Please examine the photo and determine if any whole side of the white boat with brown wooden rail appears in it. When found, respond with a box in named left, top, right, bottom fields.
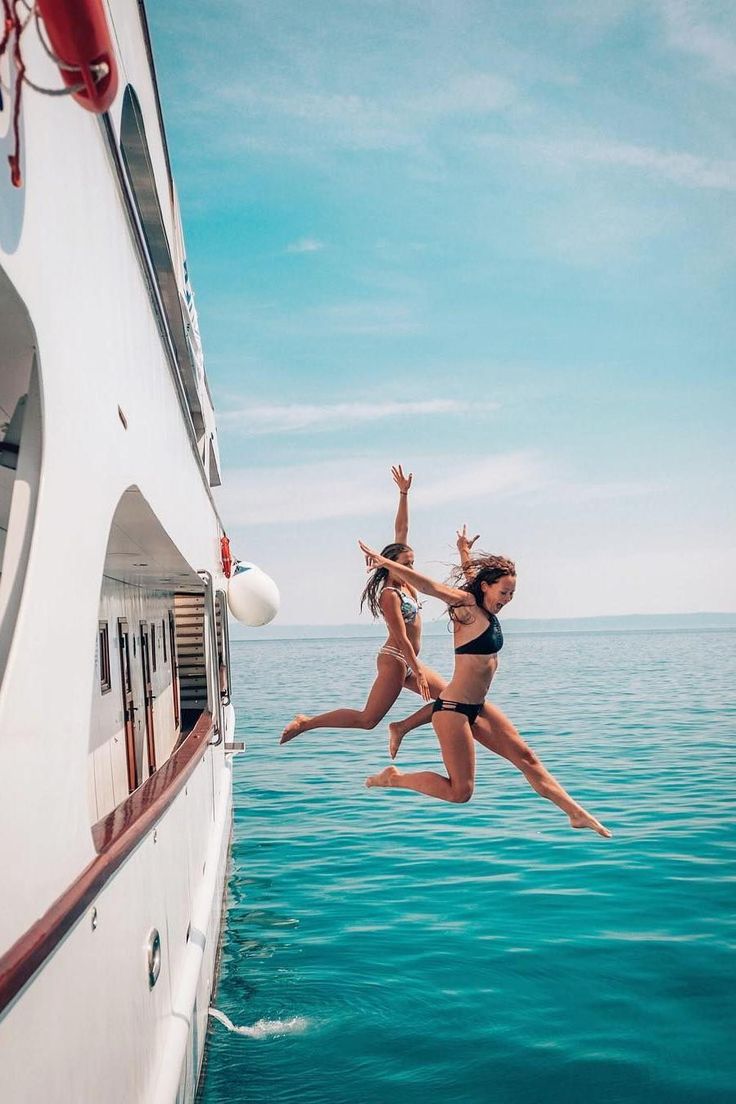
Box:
left=0, top=0, right=234, bottom=1104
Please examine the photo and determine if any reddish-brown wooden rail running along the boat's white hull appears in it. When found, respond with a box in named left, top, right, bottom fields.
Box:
left=0, top=712, right=213, bottom=1015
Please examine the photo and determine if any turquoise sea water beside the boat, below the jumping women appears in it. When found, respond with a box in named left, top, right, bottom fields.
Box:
left=201, top=631, right=736, bottom=1104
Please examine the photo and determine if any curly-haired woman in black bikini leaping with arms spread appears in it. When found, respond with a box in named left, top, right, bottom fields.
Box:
left=359, top=530, right=611, bottom=838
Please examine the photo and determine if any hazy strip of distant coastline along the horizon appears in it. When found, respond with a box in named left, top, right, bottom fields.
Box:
left=231, top=613, right=736, bottom=640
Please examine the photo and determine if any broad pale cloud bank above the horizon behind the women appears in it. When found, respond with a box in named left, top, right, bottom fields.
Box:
left=217, top=470, right=736, bottom=627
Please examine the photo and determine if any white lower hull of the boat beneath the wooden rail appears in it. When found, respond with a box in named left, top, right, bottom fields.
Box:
left=0, top=733, right=231, bottom=1104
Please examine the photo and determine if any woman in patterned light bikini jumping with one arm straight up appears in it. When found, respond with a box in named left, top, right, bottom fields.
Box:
left=280, top=464, right=445, bottom=744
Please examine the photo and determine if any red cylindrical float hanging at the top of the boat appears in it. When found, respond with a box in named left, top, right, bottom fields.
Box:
left=36, top=0, right=118, bottom=115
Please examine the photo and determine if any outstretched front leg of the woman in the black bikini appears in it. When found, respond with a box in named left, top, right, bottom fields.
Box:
left=472, top=702, right=611, bottom=838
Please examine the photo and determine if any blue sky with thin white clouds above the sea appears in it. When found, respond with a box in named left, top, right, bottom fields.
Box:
left=148, top=0, right=736, bottom=624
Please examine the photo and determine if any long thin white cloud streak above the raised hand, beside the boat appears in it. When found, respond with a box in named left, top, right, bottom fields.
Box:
left=218, top=399, right=499, bottom=436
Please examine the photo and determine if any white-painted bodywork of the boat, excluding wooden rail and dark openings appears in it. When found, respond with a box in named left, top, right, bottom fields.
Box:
left=0, top=0, right=242, bottom=1104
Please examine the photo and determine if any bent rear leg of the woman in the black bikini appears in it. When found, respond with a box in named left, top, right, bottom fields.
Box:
left=365, top=711, right=476, bottom=803
